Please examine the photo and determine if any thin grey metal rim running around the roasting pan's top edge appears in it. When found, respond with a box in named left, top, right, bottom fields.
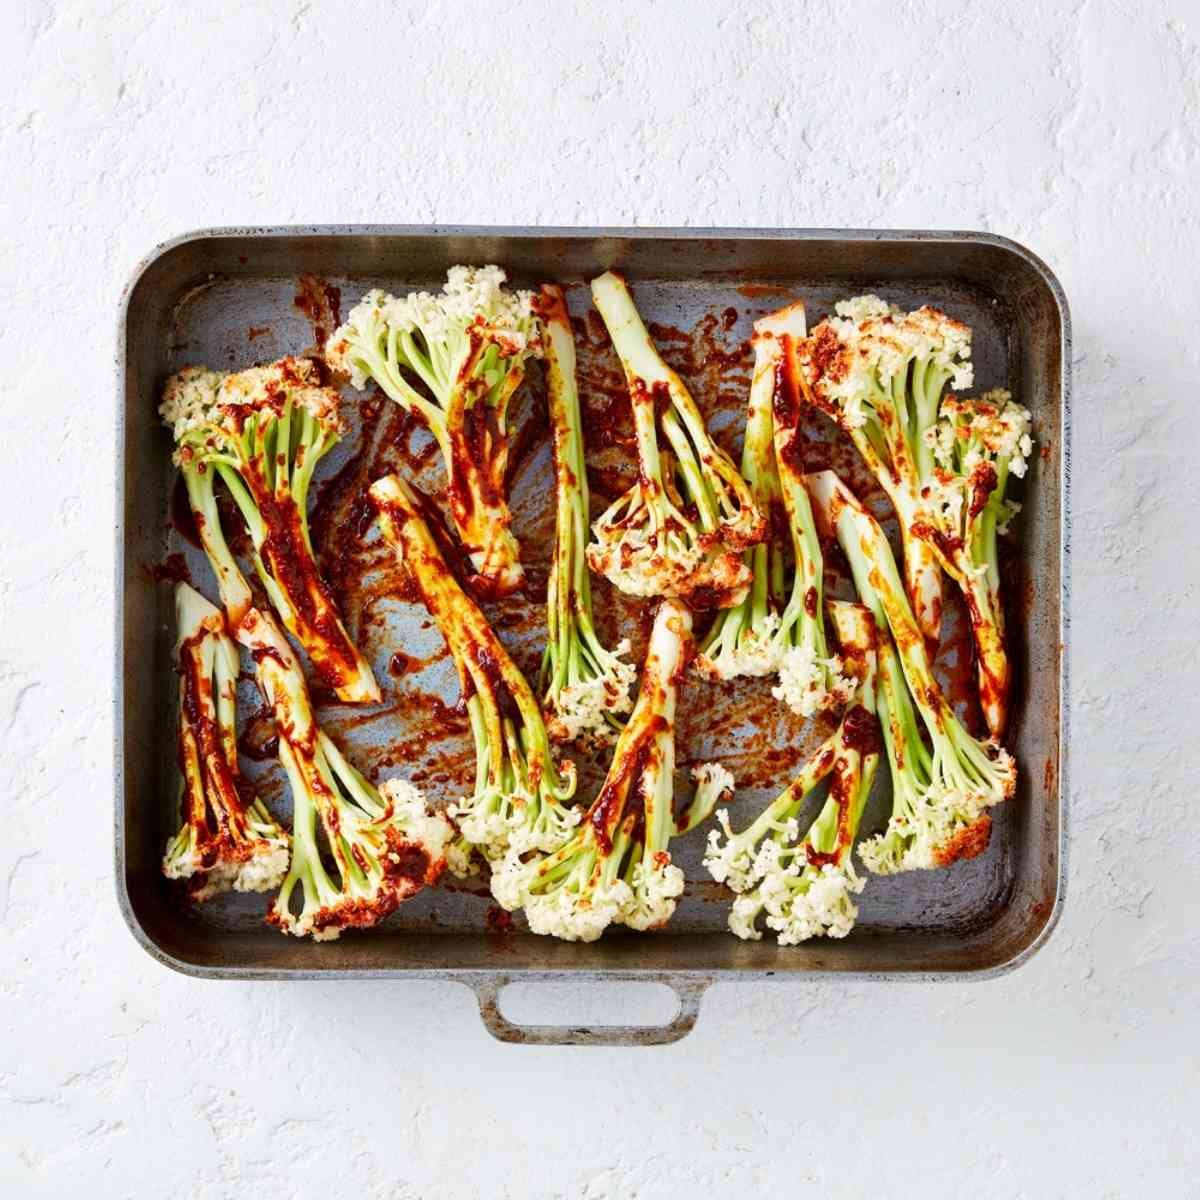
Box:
left=113, top=223, right=1073, bottom=984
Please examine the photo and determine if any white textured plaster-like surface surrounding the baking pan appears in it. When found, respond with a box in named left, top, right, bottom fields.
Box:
left=0, top=0, right=1200, bottom=1200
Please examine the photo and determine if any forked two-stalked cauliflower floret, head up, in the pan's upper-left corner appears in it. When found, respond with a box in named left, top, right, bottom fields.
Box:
left=160, top=358, right=379, bottom=703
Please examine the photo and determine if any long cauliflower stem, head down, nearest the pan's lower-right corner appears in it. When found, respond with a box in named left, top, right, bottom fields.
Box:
left=808, top=472, right=1016, bottom=874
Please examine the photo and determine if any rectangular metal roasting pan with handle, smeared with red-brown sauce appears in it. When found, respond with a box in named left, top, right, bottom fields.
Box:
left=115, top=226, right=1070, bottom=1044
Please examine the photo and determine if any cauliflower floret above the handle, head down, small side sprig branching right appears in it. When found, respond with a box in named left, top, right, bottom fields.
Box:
left=492, top=599, right=732, bottom=942
